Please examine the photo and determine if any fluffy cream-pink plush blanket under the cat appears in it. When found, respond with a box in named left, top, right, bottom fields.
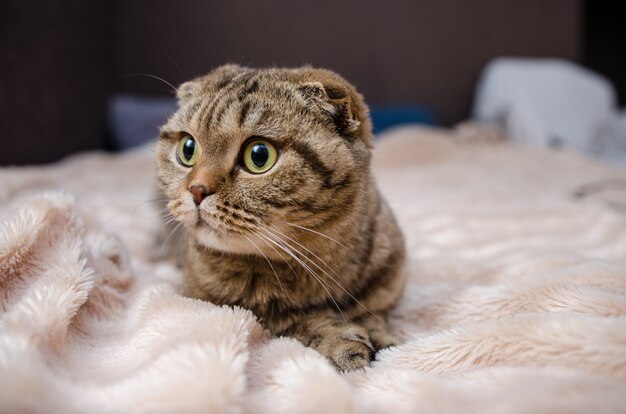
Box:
left=0, top=128, right=626, bottom=414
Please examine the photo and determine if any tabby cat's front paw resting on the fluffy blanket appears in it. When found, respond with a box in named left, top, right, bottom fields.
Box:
left=314, top=327, right=376, bottom=371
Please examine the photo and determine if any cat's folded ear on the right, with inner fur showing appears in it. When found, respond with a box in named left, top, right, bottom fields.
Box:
left=298, top=69, right=373, bottom=147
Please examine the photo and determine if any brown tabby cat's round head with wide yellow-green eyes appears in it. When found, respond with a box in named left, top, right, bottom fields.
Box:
left=157, top=65, right=372, bottom=256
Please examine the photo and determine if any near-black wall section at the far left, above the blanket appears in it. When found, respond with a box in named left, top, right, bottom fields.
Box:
left=0, top=0, right=114, bottom=165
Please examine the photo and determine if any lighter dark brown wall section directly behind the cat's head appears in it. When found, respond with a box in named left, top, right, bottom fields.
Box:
left=116, top=0, right=582, bottom=124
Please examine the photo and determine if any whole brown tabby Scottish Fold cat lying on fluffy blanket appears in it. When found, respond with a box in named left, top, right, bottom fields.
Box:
left=156, top=64, right=405, bottom=371
